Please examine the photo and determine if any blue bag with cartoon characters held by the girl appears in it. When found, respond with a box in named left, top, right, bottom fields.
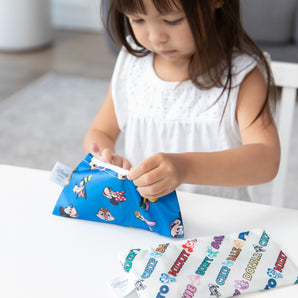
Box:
left=53, top=154, right=184, bottom=238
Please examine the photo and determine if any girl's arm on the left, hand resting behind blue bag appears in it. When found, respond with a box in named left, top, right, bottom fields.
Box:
left=84, top=84, right=131, bottom=169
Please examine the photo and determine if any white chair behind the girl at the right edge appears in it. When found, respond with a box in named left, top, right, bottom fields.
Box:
left=271, top=61, right=298, bottom=206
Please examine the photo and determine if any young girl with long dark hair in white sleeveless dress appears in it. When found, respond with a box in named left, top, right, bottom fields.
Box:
left=84, top=0, right=280, bottom=200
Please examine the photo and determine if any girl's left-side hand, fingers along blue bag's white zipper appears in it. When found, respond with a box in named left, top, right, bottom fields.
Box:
left=90, top=144, right=131, bottom=170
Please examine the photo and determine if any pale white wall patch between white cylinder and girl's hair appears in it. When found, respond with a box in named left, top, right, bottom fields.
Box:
left=50, top=0, right=103, bottom=31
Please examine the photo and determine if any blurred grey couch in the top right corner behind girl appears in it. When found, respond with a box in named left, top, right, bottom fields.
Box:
left=240, top=0, right=298, bottom=63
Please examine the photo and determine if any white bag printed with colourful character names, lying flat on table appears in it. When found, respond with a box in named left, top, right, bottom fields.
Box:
left=116, top=229, right=298, bottom=298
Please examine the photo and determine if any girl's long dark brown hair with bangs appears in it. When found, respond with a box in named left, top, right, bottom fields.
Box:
left=102, top=0, right=276, bottom=121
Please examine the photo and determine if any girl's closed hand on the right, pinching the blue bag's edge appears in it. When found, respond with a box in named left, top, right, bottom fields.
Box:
left=128, top=153, right=186, bottom=199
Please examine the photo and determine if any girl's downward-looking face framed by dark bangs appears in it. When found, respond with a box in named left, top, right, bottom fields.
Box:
left=126, top=0, right=195, bottom=63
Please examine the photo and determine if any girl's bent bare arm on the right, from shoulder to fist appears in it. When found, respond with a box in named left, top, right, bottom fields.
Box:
left=129, top=68, right=280, bottom=199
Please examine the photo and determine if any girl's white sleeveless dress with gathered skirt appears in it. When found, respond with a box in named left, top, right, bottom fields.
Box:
left=112, top=37, right=257, bottom=200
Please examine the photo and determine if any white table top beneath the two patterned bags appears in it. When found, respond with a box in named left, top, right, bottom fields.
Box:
left=0, top=165, right=298, bottom=298
